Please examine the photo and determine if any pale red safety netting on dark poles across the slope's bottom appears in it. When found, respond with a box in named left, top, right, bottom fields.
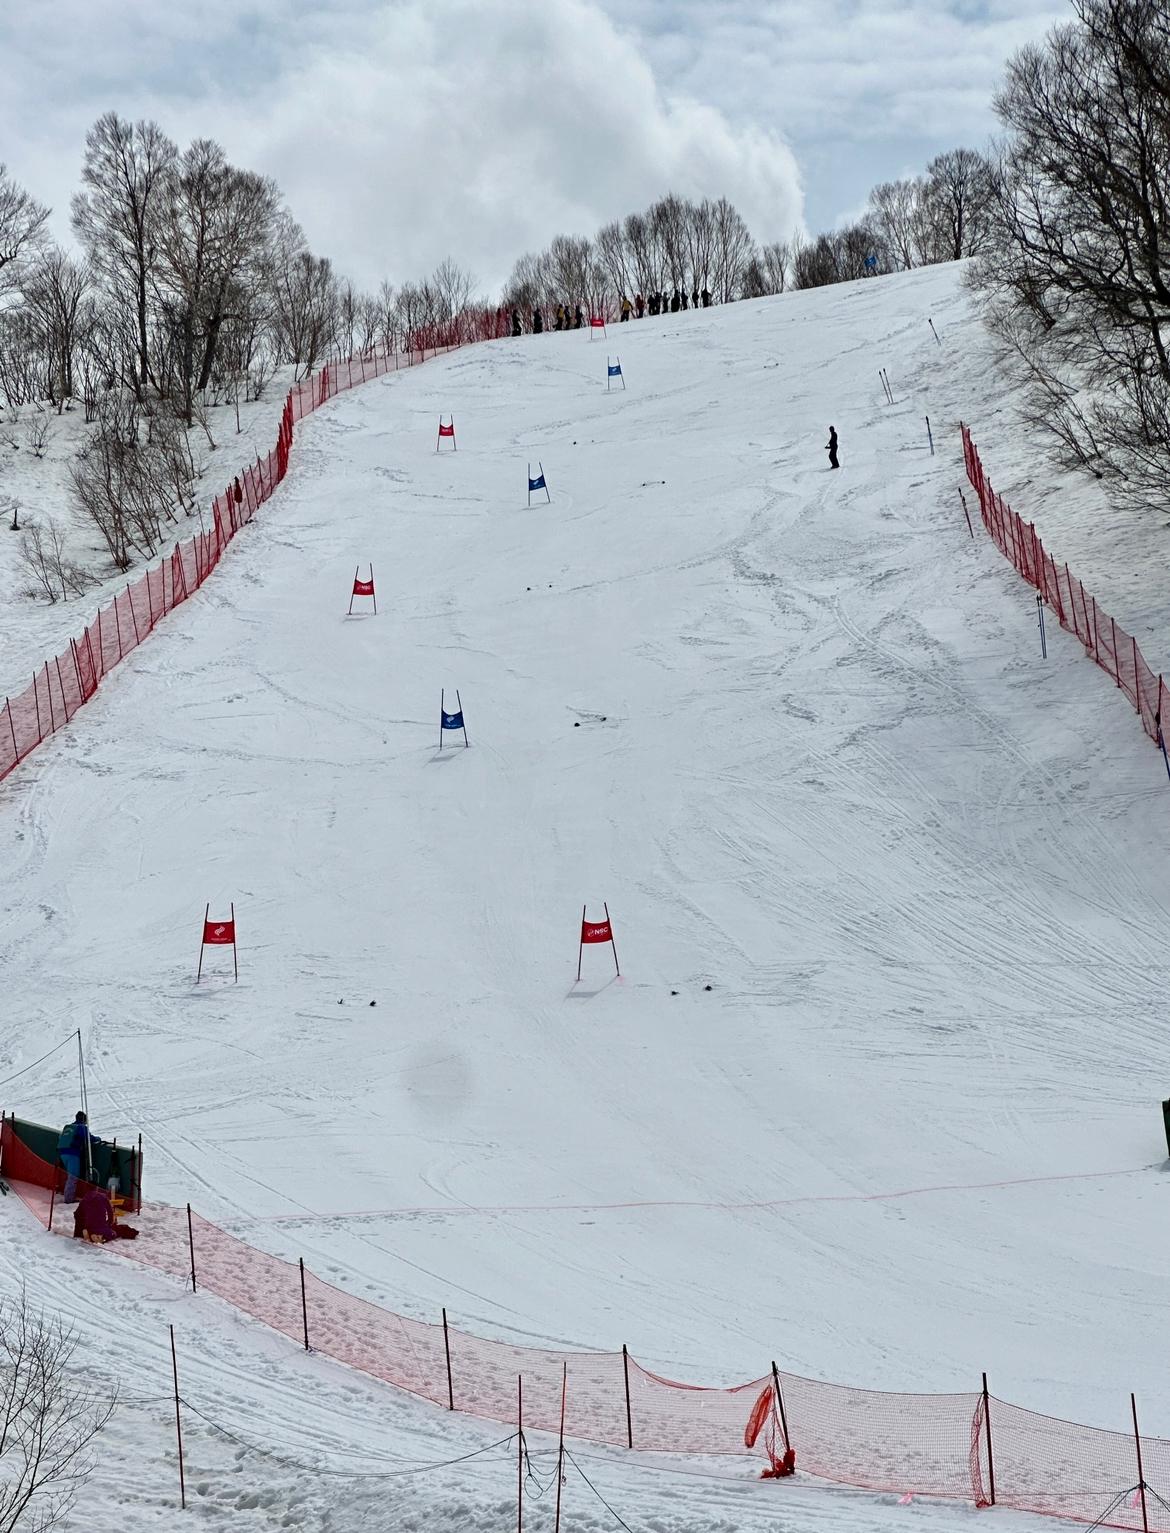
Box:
left=5, top=1128, right=1170, bottom=1533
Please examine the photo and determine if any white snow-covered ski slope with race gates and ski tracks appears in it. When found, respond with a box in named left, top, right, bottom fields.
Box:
left=0, top=270, right=1170, bottom=1530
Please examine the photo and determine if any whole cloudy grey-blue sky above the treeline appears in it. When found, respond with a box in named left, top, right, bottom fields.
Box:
left=0, top=0, right=1070, bottom=293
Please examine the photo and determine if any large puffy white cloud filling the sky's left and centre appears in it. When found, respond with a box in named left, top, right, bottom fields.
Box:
left=0, top=0, right=800, bottom=288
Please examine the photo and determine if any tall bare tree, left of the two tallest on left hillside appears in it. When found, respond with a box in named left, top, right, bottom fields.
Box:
left=72, top=112, right=176, bottom=399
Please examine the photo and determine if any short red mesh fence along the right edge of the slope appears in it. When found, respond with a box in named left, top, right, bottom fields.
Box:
left=960, top=426, right=1165, bottom=742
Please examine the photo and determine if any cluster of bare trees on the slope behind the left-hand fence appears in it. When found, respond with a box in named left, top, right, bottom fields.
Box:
left=0, top=112, right=490, bottom=579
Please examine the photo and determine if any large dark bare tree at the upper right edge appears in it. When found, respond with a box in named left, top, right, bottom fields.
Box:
left=975, top=0, right=1170, bottom=506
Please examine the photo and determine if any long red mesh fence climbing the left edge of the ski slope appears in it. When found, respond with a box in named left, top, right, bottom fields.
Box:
left=0, top=341, right=466, bottom=779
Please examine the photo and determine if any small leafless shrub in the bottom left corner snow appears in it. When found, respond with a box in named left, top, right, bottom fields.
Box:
left=0, top=1291, right=117, bottom=1533
